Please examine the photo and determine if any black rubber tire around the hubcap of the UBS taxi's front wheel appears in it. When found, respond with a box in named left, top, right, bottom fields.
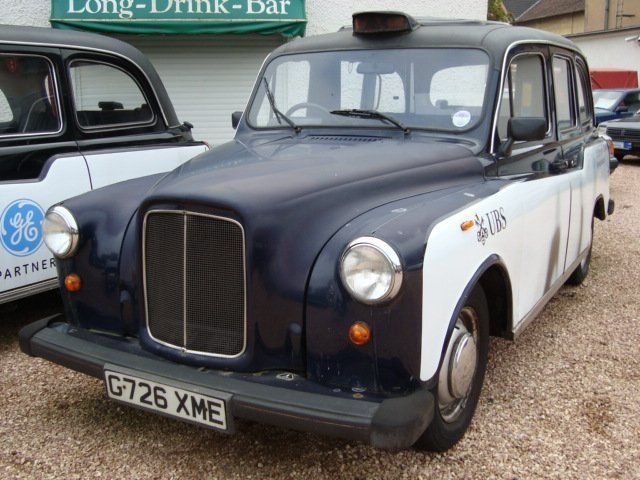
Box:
left=414, top=285, right=489, bottom=452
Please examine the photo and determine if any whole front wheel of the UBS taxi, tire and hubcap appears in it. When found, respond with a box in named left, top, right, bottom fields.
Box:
left=415, top=285, right=489, bottom=452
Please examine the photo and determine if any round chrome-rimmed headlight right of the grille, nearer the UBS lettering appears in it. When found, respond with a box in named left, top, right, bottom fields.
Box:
left=340, top=237, right=402, bottom=304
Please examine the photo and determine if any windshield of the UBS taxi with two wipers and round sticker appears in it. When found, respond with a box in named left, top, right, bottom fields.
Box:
left=248, top=48, right=489, bottom=132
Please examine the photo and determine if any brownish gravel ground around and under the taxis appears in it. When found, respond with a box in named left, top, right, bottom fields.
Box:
left=0, top=163, right=640, bottom=480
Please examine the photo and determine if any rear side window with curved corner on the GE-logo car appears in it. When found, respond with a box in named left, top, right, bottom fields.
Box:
left=69, top=60, right=154, bottom=129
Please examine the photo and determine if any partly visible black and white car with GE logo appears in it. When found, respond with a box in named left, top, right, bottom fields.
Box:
left=0, top=26, right=207, bottom=303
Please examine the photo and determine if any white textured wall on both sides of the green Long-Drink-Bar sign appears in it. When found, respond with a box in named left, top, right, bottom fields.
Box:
left=0, top=0, right=487, bottom=35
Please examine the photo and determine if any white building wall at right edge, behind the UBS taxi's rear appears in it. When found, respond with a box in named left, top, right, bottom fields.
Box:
left=570, top=27, right=640, bottom=81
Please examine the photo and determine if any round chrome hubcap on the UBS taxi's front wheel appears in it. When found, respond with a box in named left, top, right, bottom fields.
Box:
left=438, top=306, right=478, bottom=423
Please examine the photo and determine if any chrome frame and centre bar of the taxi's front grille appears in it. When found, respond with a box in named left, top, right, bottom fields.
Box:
left=142, top=209, right=247, bottom=359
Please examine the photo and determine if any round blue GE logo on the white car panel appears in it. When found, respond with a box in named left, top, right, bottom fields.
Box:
left=0, top=199, right=44, bottom=257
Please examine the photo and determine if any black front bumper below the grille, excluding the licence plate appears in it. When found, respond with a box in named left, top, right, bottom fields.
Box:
left=20, top=315, right=434, bottom=450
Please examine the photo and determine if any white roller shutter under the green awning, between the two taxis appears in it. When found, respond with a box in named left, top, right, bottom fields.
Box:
left=119, top=35, right=285, bottom=146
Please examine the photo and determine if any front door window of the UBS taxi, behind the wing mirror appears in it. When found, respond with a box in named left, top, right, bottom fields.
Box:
left=498, top=54, right=549, bottom=142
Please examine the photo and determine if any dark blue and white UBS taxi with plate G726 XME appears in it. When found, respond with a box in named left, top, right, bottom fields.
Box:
left=20, top=12, right=613, bottom=451
